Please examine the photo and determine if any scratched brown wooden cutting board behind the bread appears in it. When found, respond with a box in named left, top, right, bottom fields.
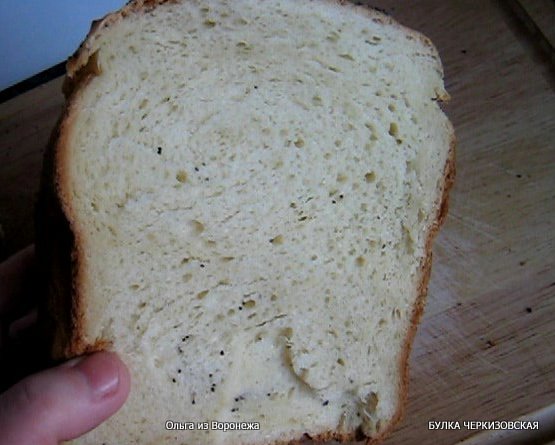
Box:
left=0, top=0, right=555, bottom=445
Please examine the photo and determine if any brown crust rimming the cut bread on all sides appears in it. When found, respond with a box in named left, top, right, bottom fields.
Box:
left=38, top=0, right=455, bottom=445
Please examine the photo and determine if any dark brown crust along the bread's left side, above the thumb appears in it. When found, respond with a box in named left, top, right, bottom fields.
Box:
left=36, top=87, right=107, bottom=360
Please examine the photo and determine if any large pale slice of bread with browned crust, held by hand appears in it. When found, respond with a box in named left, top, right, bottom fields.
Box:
left=39, top=0, right=454, bottom=445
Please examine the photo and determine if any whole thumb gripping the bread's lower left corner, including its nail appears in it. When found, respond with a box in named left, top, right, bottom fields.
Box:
left=0, top=352, right=130, bottom=445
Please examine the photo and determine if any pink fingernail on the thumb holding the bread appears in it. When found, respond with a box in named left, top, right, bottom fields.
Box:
left=72, top=352, right=119, bottom=400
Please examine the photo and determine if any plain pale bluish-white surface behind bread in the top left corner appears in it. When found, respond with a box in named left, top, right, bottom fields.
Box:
left=0, top=0, right=126, bottom=90
